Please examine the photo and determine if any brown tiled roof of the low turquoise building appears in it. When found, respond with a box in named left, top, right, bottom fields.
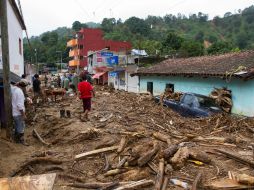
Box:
left=132, top=50, right=254, bottom=78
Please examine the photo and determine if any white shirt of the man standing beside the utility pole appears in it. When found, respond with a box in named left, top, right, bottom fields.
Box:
left=11, top=86, right=25, bottom=117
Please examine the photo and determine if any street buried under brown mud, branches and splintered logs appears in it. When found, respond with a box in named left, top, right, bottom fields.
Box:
left=0, top=86, right=254, bottom=189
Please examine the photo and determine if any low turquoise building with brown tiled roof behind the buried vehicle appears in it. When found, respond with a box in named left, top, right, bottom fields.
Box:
left=134, top=51, right=254, bottom=117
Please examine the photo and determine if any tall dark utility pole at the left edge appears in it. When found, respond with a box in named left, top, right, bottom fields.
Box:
left=0, top=0, right=12, bottom=139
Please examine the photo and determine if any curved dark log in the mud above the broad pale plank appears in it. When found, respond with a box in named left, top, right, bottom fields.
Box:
left=10, top=157, right=63, bottom=177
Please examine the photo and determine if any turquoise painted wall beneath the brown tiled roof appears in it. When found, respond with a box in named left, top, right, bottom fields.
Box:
left=139, top=76, right=254, bottom=117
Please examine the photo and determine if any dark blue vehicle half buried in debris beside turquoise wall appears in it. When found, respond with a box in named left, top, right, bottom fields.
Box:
left=155, top=93, right=222, bottom=117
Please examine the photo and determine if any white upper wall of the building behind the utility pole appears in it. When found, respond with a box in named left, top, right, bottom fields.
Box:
left=0, top=1, right=24, bottom=76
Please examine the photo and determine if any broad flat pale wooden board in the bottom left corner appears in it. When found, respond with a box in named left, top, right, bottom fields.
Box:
left=0, top=173, right=56, bottom=190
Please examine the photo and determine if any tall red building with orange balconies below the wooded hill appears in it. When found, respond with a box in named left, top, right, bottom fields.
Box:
left=67, top=28, right=131, bottom=68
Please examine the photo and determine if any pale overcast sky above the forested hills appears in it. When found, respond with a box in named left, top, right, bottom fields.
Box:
left=21, top=0, right=254, bottom=36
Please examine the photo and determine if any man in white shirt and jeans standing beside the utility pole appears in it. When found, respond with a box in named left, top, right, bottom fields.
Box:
left=11, top=83, right=27, bottom=145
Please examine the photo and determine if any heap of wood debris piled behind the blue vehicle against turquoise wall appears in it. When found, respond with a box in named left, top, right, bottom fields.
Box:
left=210, top=88, right=233, bottom=113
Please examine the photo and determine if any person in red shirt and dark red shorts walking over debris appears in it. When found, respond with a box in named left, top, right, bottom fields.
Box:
left=78, top=75, right=95, bottom=119
